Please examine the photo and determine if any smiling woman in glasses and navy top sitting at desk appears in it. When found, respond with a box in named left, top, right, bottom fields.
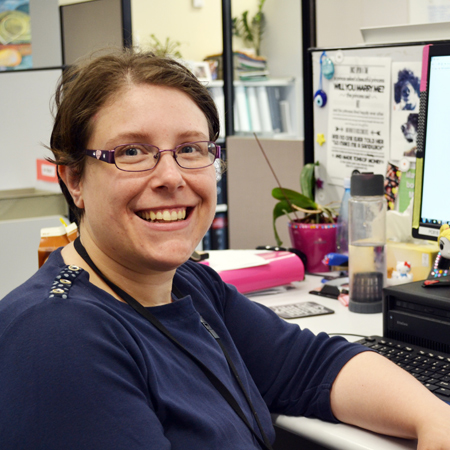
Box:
left=0, top=46, right=450, bottom=450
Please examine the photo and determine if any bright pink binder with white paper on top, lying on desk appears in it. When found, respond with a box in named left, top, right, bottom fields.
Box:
left=199, top=250, right=305, bottom=294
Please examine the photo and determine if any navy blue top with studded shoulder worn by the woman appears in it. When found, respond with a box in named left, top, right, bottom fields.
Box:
left=0, top=250, right=366, bottom=450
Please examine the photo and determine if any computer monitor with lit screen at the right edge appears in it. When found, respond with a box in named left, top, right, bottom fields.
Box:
left=412, top=44, right=450, bottom=240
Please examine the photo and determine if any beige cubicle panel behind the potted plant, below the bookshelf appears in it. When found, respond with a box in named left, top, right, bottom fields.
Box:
left=226, top=136, right=304, bottom=249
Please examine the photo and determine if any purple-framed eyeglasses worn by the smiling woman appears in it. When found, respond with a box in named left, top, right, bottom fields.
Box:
left=86, top=141, right=220, bottom=172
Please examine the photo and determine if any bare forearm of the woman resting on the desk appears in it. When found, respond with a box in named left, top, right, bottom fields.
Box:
left=331, top=352, right=450, bottom=450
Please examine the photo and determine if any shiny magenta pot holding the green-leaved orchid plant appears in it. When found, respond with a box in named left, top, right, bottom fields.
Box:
left=288, top=221, right=337, bottom=273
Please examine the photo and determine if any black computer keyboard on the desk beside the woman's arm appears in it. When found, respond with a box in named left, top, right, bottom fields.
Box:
left=357, top=336, right=450, bottom=403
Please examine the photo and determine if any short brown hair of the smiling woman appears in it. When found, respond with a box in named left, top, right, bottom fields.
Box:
left=50, top=49, right=219, bottom=222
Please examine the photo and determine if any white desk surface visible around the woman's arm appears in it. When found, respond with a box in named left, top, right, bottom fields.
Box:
left=250, top=275, right=417, bottom=450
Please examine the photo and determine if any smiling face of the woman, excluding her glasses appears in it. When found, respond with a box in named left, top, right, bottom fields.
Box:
left=74, top=85, right=217, bottom=273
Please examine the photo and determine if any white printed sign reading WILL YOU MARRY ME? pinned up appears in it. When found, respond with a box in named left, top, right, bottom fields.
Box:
left=327, top=57, right=391, bottom=184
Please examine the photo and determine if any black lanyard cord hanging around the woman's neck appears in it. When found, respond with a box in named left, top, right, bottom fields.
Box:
left=74, top=237, right=273, bottom=450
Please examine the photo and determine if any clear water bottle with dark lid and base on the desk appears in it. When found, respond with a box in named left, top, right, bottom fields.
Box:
left=348, top=173, right=386, bottom=313
